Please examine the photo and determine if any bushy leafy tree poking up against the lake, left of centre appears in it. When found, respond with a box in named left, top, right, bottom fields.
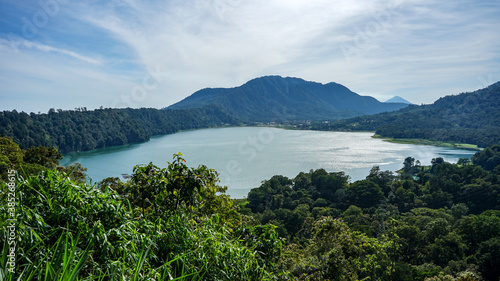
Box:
left=123, top=153, right=237, bottom=222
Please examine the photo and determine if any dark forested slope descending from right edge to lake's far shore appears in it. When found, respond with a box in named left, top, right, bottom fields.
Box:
left=310, top=82, right=500, bottom=147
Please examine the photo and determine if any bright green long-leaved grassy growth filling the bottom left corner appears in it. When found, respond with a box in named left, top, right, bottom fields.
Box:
left=0, top=167, right=280, bottom=280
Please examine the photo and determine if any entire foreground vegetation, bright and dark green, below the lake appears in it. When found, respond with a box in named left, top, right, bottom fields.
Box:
left=0, top=138, right=500, bottom=281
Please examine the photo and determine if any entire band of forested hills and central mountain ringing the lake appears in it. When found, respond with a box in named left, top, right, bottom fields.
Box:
left=0, top=79, right=500, bottom=153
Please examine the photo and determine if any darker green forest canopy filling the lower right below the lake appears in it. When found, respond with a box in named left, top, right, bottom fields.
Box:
left=246, top=145, right=500, bottom=281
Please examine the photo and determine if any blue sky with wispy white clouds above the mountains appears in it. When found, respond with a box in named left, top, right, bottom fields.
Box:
left=0, top=0, right=500, bottom=112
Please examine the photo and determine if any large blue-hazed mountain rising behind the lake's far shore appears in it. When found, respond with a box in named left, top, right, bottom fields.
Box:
left=167, top=76, right=407, bottom=122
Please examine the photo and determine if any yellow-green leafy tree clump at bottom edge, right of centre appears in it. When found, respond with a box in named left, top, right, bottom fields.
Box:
left=282, top=217, right=398, bottom=280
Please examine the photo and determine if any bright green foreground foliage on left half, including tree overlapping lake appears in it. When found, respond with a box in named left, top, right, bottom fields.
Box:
left=0, top=154, right=281, bottom=280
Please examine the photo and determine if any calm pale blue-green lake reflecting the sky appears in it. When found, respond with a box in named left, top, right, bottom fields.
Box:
left=61, top=127, right=475, bottom=198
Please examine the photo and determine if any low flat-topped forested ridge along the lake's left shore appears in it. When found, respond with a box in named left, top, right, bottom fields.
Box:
left=0, top=106, right=237, bottom=153
